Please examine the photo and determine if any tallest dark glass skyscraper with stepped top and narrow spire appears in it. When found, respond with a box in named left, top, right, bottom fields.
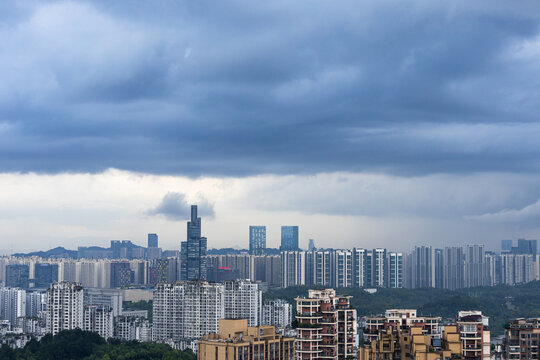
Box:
left=180, top=205, right=207, bottom=280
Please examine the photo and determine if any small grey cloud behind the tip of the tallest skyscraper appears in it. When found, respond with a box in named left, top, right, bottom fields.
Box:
left=146, top=192, right=215, bottom=221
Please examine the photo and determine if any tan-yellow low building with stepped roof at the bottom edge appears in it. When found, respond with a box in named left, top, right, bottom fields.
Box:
left=197, top=319, right=295, bottom=360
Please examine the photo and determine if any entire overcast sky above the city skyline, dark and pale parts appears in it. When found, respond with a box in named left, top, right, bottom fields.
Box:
left=0, top=0, right=540, bottom=254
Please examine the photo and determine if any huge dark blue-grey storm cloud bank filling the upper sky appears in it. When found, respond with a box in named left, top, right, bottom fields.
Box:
left=0, top=1, right=540, bottom=176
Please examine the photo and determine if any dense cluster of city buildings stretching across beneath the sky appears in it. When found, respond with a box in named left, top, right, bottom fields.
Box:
left=0, top=206, right=540, bottom=360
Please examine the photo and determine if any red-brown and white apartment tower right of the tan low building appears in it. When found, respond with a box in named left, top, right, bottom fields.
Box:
left=296, top=289, right=356, bottom=360
